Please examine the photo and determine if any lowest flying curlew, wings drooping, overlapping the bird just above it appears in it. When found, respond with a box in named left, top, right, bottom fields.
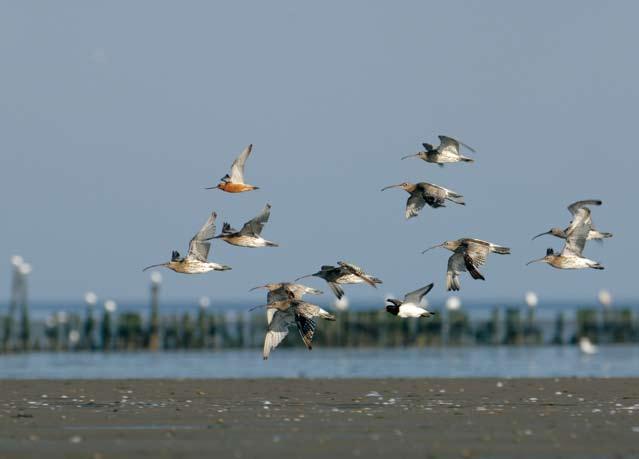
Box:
left=252, top=291, right=335, bottom=360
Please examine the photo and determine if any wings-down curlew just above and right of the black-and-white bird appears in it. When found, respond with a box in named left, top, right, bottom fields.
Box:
left=422, top=238, right=510, bottom=291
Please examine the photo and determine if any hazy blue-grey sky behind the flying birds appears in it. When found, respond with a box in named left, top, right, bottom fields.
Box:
left=0, top=1, right=639, bottom=301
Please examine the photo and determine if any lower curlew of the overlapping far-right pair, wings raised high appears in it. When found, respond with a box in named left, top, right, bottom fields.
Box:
left=526, top=206, right=604, bottom=269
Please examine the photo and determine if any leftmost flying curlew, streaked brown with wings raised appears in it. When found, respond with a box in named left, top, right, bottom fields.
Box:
left=143, top=212, right=231, bottom=274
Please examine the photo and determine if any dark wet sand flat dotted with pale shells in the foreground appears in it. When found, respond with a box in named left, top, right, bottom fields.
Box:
left=0, top=379, right=639, bottom=459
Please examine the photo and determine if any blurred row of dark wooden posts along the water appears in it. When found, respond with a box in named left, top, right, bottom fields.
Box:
left=0, top=308, right=639, bottom=352
